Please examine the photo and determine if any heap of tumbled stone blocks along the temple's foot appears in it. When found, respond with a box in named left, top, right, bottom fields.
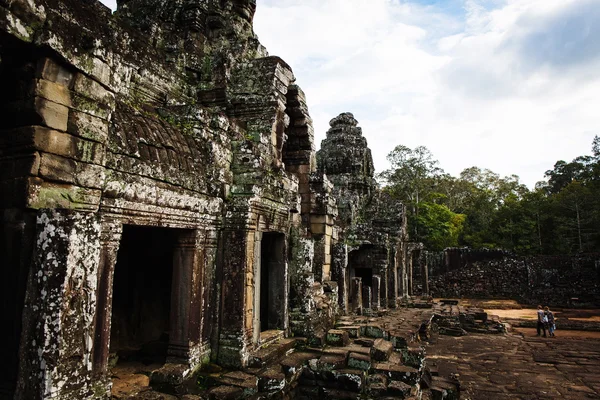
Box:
left=168, top=309, right=460, bottom=400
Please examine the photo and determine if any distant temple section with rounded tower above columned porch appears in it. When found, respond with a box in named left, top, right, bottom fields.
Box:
left=317, top=113, right=408, bottom=314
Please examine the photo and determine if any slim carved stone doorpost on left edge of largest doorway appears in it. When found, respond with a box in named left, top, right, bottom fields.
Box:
left=93, top=220, right=123, bottom=386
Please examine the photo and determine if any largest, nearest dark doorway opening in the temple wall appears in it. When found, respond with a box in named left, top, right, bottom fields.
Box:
left=110, top=225, right=178, bottom=364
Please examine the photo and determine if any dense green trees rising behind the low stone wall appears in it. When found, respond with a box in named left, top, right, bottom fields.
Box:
left=378, top=136, right=600, bottom=254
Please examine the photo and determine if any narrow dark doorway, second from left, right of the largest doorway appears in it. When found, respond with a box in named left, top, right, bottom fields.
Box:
left=260, top=232, right=287, bottom=332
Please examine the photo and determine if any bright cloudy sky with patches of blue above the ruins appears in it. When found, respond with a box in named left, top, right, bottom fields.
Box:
left=105, top=0, right=600, bottom=186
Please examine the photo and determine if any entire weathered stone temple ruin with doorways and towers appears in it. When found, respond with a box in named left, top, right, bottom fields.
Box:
left=0, top=0, right=426, bottom=399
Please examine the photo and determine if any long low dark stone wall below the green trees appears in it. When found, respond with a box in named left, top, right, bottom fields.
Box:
left=429, top=249, right=600, bottom=307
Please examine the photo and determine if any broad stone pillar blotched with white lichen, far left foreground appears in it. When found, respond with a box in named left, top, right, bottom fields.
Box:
left=15, top=210, right=101, bottom=400
